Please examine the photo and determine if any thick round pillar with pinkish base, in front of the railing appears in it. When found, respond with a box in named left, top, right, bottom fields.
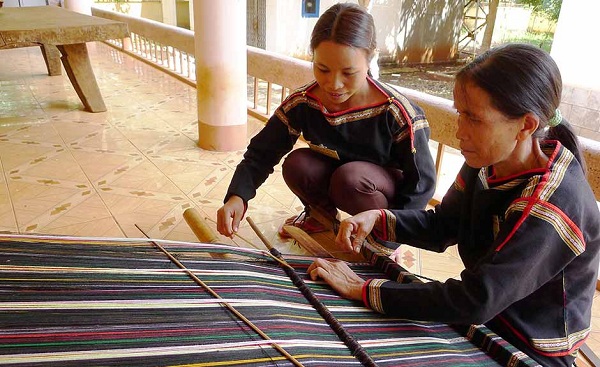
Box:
left=194, top=0, right=248, bottom=151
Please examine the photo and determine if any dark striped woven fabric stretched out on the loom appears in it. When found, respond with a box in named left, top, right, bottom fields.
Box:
left=0, top=236, right=536, bottom=366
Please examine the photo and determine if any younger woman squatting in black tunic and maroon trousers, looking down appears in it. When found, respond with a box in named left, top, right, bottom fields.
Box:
left=217, top=3, right=435, bottom=236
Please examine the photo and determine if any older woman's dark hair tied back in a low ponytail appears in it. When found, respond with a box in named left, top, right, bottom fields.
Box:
left=456, top=43, right=586, bottom=173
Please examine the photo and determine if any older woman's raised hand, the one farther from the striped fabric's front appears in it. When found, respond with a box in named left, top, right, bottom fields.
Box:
left=335, top=209, right=381, bottom=253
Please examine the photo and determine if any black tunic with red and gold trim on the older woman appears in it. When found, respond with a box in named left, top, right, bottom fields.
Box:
left=363, top=141, right=600, bottom=366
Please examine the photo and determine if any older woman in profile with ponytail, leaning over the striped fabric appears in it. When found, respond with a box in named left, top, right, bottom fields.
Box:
left=309, top=44, right=600, bottom=366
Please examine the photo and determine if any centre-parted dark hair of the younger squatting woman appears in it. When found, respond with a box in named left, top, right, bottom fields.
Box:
left=310, top=3, right=377, bottom=61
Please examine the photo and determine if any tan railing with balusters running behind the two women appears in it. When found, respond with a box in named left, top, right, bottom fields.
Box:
left=92, top=8, right=600, bottom=200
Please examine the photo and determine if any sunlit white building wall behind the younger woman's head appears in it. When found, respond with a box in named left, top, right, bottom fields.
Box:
left=266, top=0, right=462, bottom=63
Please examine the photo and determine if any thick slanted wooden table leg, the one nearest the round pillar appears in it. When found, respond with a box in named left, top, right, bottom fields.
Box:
left=57, top=43, right=106, bottom=112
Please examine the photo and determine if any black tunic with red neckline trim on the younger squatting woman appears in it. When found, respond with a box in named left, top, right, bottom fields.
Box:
left=225, top=78, right=435, bottom=208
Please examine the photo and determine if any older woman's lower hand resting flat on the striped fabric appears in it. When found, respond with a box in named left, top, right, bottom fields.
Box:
left=308, top=259, right=365, bottom=301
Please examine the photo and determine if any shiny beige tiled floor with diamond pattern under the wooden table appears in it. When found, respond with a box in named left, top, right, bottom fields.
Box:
left=0, top=43, right=600, bottom=358
